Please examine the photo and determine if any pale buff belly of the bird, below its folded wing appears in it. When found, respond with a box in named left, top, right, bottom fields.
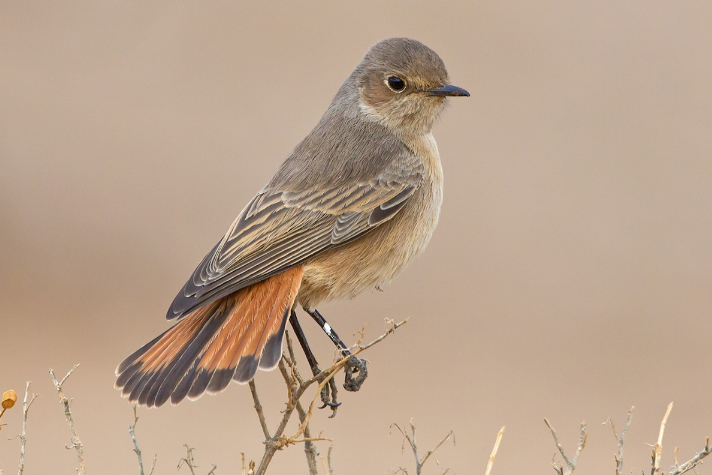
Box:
left=297, top=183, right=442, bottom=308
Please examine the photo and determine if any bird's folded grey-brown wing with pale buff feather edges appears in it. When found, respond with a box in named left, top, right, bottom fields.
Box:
left=167, top=153, right=424, bottom=319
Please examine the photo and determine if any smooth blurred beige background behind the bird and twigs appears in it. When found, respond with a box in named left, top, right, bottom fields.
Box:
left=0, top=0, right=712, bottom=475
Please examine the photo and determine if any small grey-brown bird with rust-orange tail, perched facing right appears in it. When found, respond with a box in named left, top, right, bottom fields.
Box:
left=116, top=38, right=469, bottom=406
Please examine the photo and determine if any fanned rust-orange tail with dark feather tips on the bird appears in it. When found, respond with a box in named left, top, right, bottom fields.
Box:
left=116, top=267, right=303, bottom=407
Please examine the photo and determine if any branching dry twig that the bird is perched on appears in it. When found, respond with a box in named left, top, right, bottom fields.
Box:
left=253, top=319, right=408, bottom=475
